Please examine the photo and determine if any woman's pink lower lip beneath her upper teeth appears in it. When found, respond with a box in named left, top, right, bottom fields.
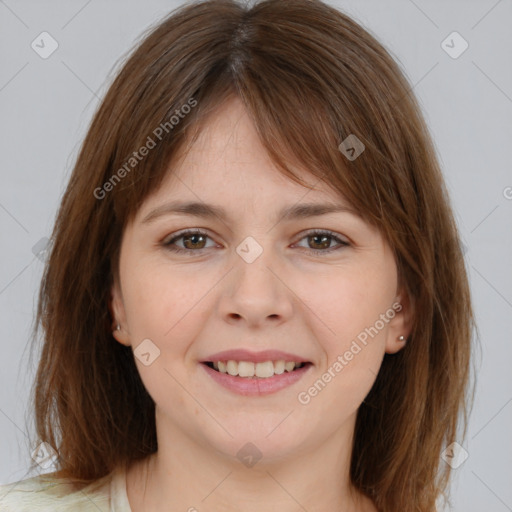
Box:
left=201, top=363, right=313, bottom=396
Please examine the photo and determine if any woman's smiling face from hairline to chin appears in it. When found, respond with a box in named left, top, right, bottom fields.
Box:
left=112, top=96, right=408, bottom=464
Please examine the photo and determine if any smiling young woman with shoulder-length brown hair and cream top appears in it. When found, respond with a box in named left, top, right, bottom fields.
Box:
left=0, top=0, right=473, bottom=512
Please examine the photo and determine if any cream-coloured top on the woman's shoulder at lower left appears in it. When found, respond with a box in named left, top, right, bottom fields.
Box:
left=0, top=468, right=131, bottom=512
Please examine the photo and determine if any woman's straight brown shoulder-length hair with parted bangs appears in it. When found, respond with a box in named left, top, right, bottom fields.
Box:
left=22, top=0, right=474, bottom=512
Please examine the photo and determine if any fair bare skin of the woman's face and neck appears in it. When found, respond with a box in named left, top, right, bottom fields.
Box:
left=111, top=99, right=411, bottom=512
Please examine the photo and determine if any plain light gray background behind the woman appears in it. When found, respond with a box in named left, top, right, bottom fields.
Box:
left=0, top=0, right=512, bottom=512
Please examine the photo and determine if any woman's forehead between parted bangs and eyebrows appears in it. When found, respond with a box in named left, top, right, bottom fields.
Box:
left=140, top=98, right=348, bottom=215
